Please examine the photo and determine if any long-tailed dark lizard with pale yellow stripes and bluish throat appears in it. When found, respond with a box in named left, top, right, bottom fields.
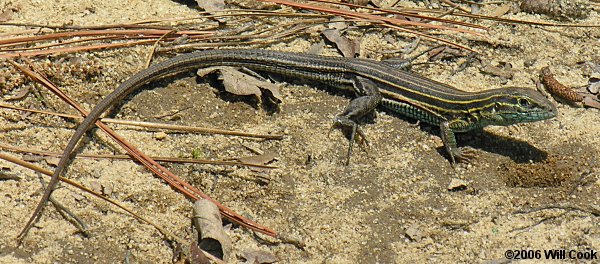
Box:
left=22, top=49, right=557, bottom=239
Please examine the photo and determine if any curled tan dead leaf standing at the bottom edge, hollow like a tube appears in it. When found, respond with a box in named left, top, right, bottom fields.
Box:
left=192, top=199, right=231, bottom=261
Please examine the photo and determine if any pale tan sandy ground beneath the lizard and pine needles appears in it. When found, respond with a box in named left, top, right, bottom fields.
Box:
left=0, top=0, right=600, bottom=263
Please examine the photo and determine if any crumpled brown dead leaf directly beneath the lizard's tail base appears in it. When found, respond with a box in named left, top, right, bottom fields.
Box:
left=197, top=66, right=283, bottom=102
